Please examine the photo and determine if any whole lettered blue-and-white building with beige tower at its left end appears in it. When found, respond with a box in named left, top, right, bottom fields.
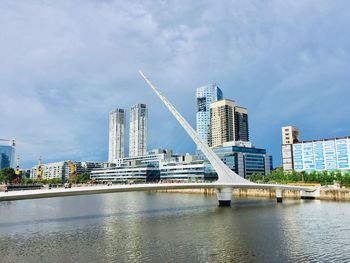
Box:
left=282, top=126, right=350, bottom=172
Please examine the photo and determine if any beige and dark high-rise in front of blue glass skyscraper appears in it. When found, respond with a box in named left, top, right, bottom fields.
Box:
left=209, top=99, right=249, bottom=147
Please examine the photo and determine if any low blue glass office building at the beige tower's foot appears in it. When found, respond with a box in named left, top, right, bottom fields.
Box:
left=200, top=141, right=273, bottom=178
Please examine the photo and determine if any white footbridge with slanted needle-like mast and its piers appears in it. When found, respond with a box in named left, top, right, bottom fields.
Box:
left=0, top=70, right=319, bottom=206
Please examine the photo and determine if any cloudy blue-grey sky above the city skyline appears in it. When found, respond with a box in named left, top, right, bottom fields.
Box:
left=0, top=0, right=350, bottom=168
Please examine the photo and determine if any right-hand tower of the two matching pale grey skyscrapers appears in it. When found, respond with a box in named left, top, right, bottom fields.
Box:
left=129, top=104, right=147, bottom=157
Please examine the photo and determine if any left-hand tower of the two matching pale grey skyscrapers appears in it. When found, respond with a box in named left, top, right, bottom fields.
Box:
left=108, top=109, right=125, bottom=162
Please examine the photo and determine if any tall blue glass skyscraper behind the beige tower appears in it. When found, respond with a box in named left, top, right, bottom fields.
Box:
left=196, top=84, right=223, bottom=145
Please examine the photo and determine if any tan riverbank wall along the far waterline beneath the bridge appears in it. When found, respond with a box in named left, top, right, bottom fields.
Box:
left=156, top=188, right=350, bottom=201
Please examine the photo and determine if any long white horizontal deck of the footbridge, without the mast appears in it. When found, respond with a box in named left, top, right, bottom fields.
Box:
left=0, top=182, right=315, bottom=201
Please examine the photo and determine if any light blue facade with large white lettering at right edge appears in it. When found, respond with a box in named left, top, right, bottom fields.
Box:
left=292, top=137, right=350, bottom=171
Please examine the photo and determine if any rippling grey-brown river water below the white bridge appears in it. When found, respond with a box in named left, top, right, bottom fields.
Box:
left=0, top=192, right=350, bottom=263
